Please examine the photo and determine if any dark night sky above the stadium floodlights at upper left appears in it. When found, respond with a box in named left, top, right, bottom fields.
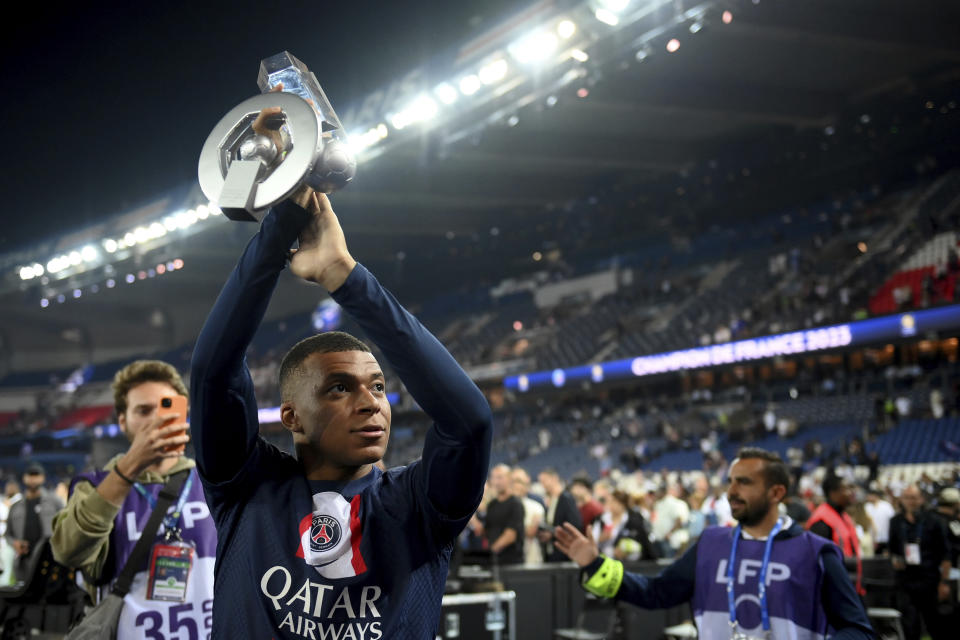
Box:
left=0, top=0, right=530, bottom=252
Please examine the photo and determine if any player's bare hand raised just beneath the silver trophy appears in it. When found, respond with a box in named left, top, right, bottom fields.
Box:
left=290, top=191, right=357, bottom=291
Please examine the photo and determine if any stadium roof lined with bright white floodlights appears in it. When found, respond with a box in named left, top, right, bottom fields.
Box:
left=0, top=0, right=960, bottom=373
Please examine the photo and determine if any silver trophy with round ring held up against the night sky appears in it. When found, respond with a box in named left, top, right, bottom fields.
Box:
left=197, top=51, right=357, bottom=221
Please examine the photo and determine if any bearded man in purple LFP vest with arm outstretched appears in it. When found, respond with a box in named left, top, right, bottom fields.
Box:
left=556, top=448, right=873, bottom=640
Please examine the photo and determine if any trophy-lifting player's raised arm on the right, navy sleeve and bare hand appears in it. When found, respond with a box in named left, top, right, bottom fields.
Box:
left=290, top=194, right=493, bottom=520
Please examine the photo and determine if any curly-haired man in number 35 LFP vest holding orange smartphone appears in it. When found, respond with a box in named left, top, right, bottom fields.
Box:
left=50, top=360, right=217, bottom=640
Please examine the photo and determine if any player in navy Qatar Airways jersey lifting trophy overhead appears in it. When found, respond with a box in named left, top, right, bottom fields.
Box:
left=191, top=182, right=492, bottom=640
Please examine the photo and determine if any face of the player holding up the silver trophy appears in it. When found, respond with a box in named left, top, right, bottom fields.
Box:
left=292, top=351, right=390, bottom=467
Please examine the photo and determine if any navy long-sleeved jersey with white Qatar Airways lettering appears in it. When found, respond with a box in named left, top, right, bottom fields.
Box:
left=190, top=202, right=492, bottom=640
